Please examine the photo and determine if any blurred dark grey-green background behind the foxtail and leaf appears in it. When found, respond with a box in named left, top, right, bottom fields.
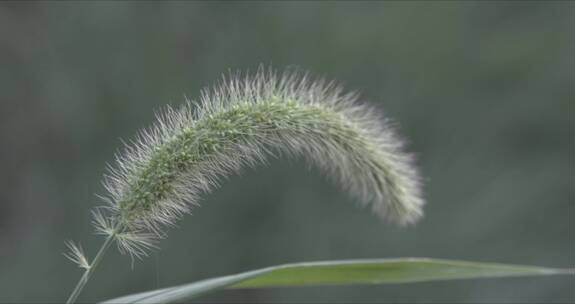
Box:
left=0, top=1, right=575, bottom=303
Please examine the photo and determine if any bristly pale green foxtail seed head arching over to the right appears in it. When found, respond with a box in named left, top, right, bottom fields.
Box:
left=83, top=69, right=424, bottom=258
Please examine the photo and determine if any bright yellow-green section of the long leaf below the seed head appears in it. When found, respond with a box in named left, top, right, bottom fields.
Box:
left=232, top=259, right=557, bottom=288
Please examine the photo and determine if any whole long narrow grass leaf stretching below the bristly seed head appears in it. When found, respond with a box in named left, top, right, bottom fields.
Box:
left=104, top=258, right=575, bottom=303
